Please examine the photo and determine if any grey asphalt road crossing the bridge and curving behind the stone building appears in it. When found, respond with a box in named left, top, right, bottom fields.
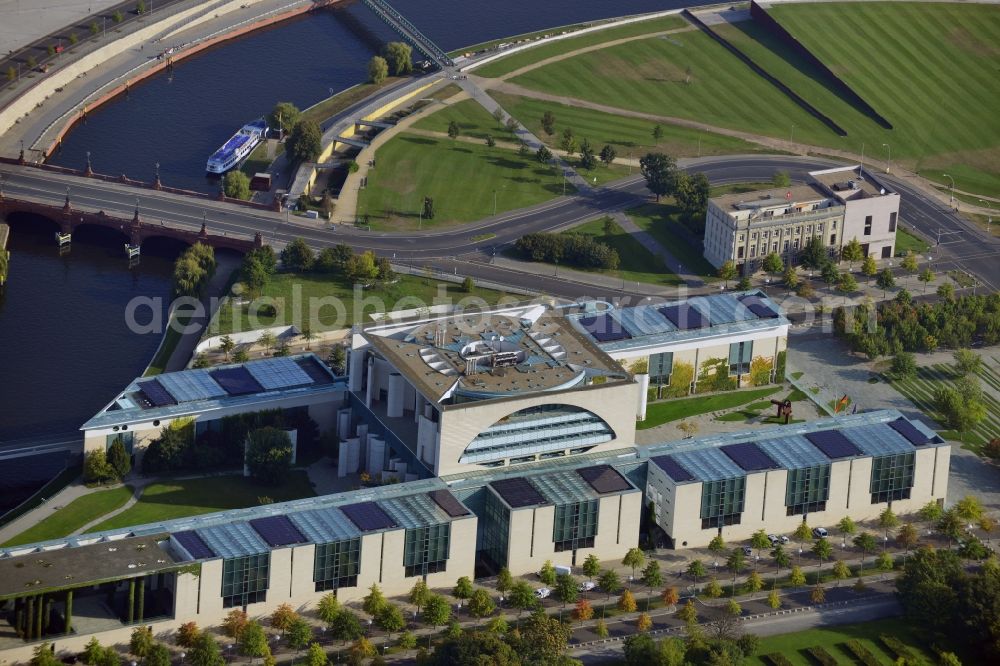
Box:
left=0, top=155, right=1000, bottom=298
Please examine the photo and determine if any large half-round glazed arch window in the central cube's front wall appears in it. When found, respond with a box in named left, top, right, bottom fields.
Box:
left=459, top=405, right=615, bottom=464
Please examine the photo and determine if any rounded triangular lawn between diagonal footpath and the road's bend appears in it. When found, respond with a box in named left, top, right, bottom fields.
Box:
left=358, top=132, right=575, bottom=231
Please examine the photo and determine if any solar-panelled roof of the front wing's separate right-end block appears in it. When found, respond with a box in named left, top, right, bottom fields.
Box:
left=640, top=410, right=948, bottom=483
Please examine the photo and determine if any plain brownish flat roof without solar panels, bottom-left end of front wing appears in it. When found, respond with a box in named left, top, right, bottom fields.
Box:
left=0, top=534, right=182, bottom=598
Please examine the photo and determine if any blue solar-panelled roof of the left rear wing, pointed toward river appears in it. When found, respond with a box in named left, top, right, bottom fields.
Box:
left=80, top=353, right=347, bottom=430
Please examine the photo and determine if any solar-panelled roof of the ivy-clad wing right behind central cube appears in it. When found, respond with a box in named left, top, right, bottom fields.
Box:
left=567, top=289, right=789, bottom=354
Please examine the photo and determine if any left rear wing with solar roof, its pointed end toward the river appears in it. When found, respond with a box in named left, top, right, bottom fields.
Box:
left=80, top=354, right=347, bottom=454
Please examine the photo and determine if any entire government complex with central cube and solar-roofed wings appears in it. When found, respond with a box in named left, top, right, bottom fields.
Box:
left=0, top=291, right=950, bottom=661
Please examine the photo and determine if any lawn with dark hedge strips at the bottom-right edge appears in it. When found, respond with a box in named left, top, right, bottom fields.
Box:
left=745, top=618, right=938, bottom=666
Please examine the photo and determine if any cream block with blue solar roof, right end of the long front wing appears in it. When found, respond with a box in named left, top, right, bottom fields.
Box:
left=642, top=410, right=951, bottom=548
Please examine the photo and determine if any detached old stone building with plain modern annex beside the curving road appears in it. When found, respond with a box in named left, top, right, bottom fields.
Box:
left=704, top=166, right=899, bottom=275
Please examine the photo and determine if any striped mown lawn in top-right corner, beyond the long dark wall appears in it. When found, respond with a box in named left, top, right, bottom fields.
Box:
left=768, top=2, right=1000, bottom=195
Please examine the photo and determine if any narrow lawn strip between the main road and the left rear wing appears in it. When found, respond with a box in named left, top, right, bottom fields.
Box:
left=205, top=273, right=517, bottom=336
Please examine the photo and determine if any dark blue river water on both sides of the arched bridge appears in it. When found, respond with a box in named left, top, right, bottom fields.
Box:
left=0, top=0, right=699, bottom=482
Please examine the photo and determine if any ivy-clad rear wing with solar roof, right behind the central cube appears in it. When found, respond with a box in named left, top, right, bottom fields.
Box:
left=567, top=290, right=789, bottom=404
